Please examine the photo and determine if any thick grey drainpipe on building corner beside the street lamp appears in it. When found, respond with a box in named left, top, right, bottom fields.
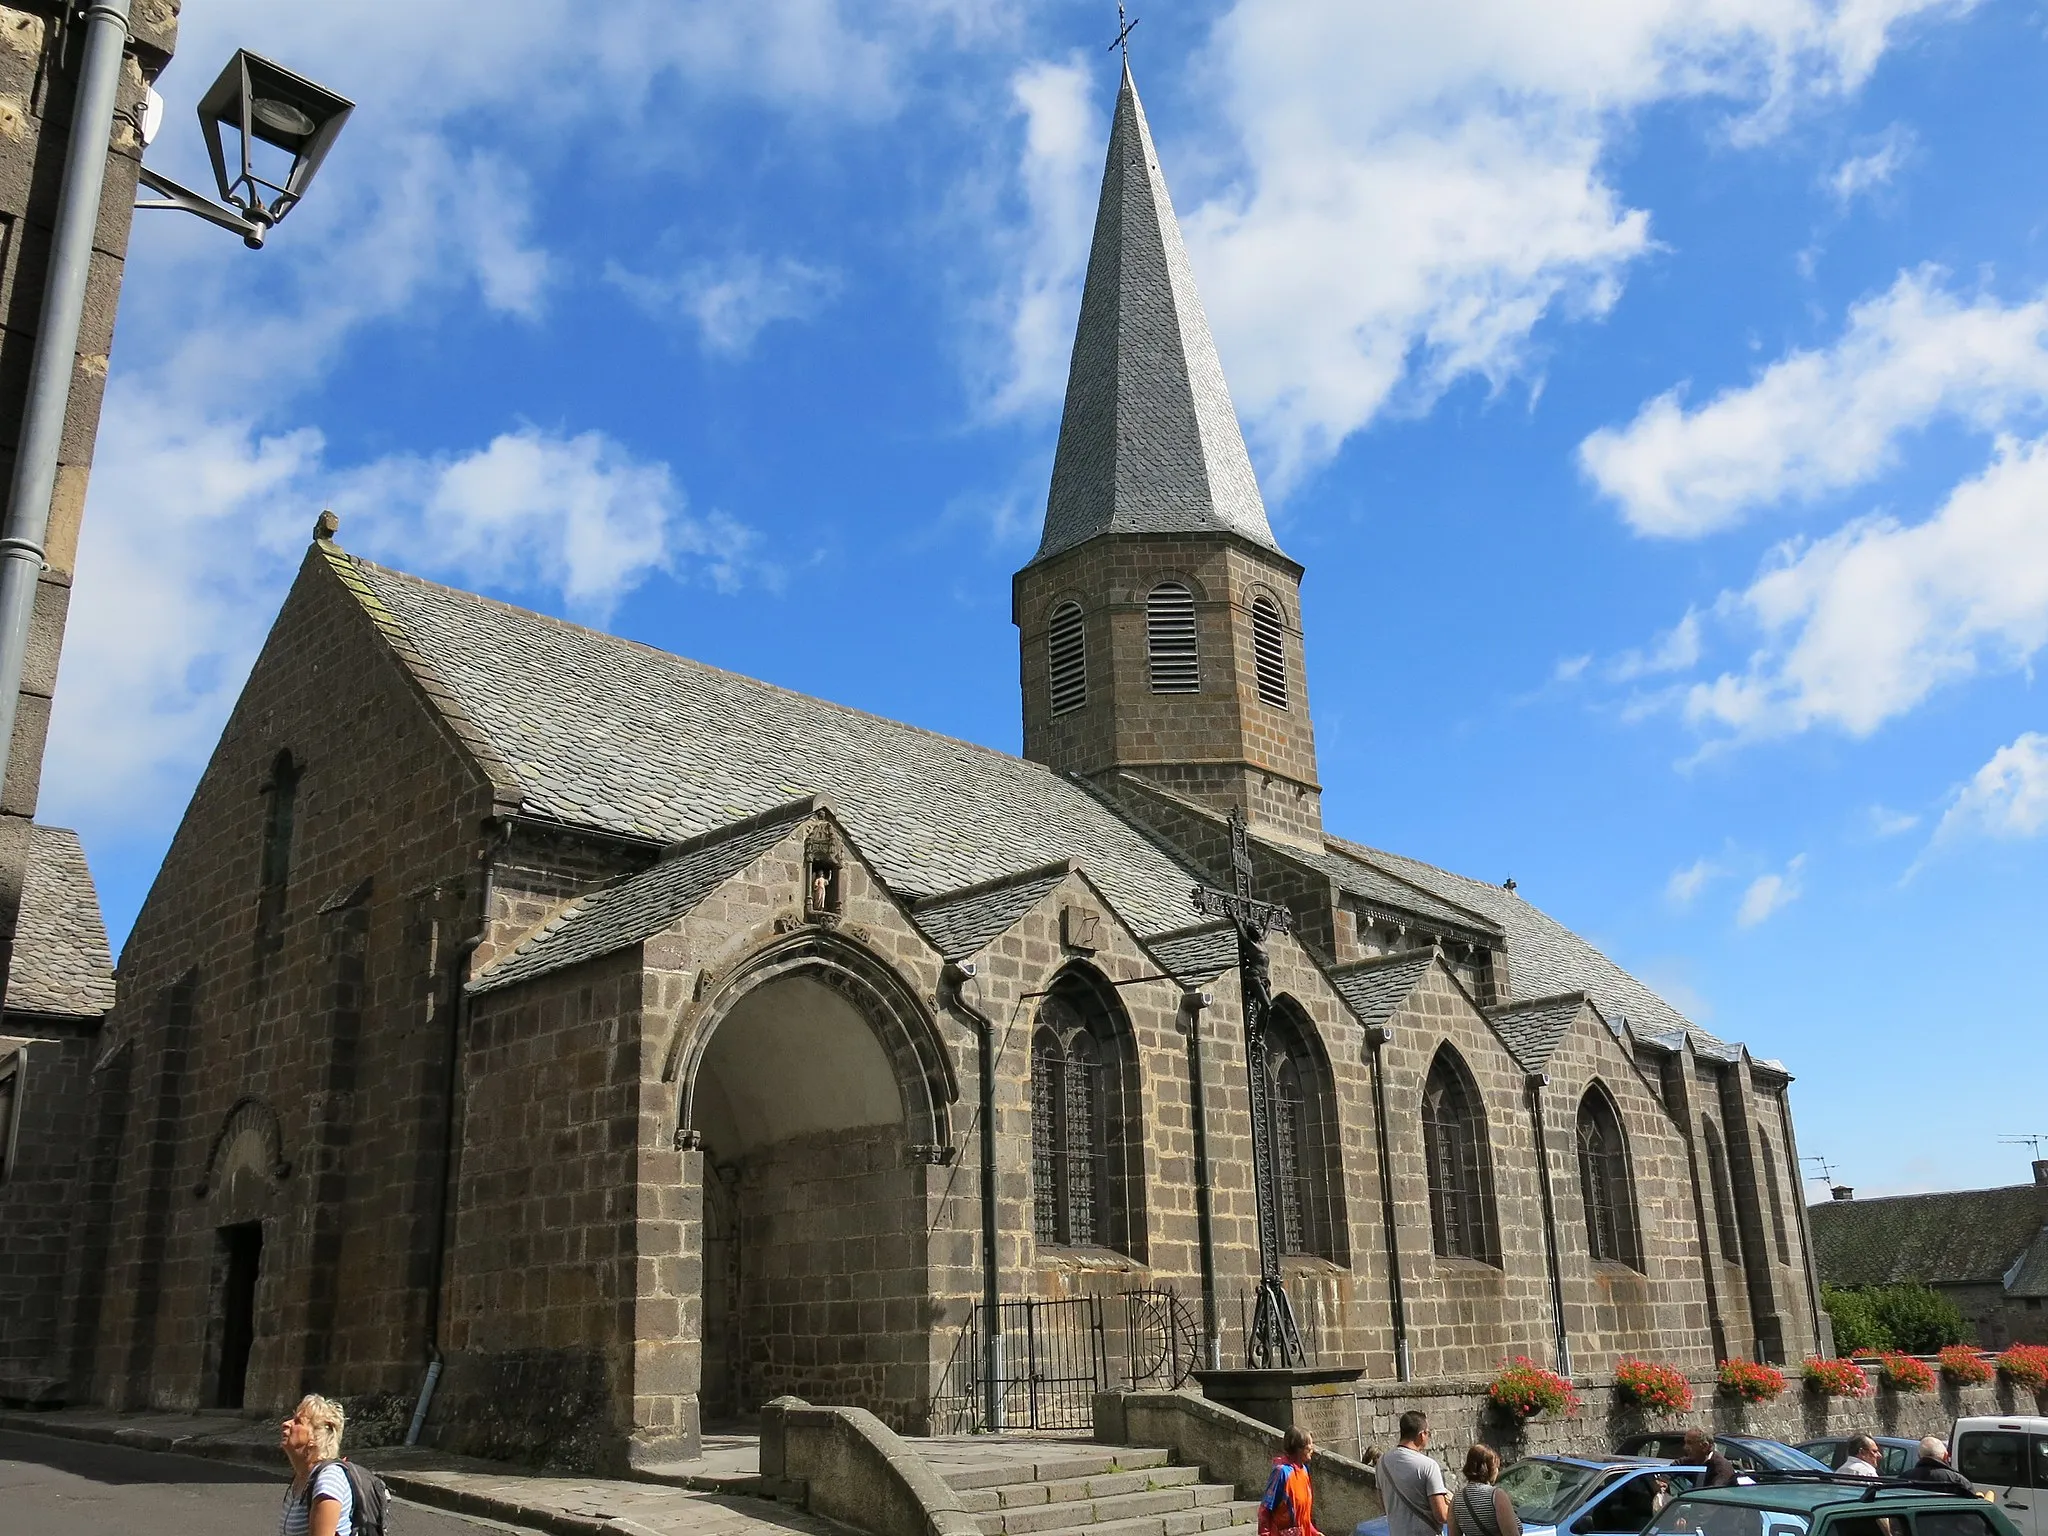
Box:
left=0, top=0, right=129, bottom=794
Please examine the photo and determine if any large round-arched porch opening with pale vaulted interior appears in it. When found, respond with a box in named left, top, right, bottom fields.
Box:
left=686, top=963, right=942, bottom=1427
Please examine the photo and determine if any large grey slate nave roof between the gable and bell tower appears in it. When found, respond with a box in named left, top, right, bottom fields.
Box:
left=335, top=545, right=1196, bottom=934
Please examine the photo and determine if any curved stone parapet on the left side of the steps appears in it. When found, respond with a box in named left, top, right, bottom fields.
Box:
left=762, top=1397, right=981, bottom=1536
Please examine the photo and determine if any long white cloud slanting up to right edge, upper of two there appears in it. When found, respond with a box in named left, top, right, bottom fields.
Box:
left=1579, top=268, right=2048, bottom=539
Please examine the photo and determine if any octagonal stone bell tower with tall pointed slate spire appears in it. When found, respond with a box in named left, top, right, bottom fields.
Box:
left=1012, top=63, right=1323, bottom=842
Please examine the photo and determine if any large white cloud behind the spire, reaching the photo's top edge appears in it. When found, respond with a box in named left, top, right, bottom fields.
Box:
left=987, top=0, right=1968, bottom=487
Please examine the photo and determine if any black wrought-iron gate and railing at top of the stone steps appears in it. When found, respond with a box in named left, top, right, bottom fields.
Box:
left=932, top=1290, right=1202, bottom=1434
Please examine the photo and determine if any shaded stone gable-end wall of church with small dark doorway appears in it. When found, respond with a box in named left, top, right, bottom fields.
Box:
left=87, top=549, right=496, bottom=1409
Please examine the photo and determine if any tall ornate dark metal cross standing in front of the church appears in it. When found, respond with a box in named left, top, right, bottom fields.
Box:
left=1194, top=807, right=1307, bottom=1370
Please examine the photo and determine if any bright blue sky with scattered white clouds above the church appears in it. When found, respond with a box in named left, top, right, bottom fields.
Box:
left=56, top=0, right=2048, bottom=1192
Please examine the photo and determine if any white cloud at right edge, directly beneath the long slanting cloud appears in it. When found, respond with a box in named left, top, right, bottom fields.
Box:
left=1683, top=440, right=2048, bottom=737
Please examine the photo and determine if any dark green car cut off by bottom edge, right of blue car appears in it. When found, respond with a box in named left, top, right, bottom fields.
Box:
left=1642, top=1473, right=2025, bottom=1536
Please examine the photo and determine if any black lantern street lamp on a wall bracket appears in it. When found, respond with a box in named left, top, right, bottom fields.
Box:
left=135, top=49, right=356, bottom=250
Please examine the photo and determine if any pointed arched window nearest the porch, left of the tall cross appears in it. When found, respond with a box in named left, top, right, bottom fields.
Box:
left=1030, top=973, right=1139, bottom=1257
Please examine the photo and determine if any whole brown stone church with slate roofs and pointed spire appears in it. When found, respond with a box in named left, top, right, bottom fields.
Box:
left=0, top=74, right=1821, bottom=1464
